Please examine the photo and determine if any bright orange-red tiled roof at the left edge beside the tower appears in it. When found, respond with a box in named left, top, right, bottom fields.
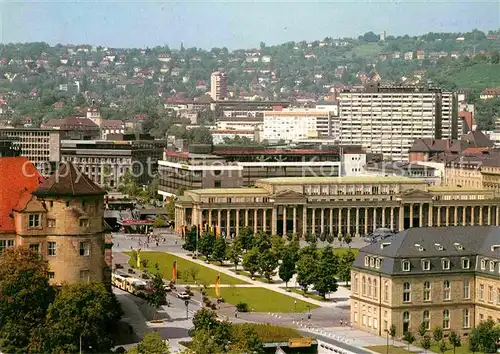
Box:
left=0, top=157, right=40, bottom=233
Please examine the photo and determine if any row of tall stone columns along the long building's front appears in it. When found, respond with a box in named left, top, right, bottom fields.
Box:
left=175, top=203, right=500, bottom=235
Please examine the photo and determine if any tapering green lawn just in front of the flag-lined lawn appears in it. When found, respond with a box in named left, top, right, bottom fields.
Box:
left=206, top=287, right=318, bottom=313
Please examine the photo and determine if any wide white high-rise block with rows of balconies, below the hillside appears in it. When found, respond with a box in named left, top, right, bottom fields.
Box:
left=338, top=84, right=462, bottom=160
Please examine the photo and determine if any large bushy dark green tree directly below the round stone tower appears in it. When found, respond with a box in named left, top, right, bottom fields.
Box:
left=43, top=283, right=121, bottom=353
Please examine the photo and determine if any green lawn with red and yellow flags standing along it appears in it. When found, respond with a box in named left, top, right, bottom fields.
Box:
left=125, top=252, right=248, bottom=285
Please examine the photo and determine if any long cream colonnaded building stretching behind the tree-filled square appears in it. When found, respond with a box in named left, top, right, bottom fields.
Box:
left=175, top=177, right=500, bottom=236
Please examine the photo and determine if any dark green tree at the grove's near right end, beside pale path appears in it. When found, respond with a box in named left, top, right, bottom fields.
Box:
left=313, top=246, right=339, bottom=298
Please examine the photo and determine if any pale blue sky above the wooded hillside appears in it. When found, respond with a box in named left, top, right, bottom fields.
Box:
left=0, top=0, right=500, bottom=50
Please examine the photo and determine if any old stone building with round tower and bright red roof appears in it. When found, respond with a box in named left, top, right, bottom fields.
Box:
left=0, top=157, right=111, bottom=284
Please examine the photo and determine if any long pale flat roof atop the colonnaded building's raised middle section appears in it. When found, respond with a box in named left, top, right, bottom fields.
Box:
left=257, top=176, right=425, bottom=184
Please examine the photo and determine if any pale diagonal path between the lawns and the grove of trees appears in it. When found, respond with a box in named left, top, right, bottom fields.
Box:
left=172, top=253, right=349, bottom=307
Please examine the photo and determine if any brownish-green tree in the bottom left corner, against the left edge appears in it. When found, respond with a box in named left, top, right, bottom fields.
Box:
left=0, top=247, right=54, bottom=353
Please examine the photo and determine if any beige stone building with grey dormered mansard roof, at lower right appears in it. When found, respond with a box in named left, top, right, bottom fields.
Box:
left=350, top=226, right=500, bottom=337
